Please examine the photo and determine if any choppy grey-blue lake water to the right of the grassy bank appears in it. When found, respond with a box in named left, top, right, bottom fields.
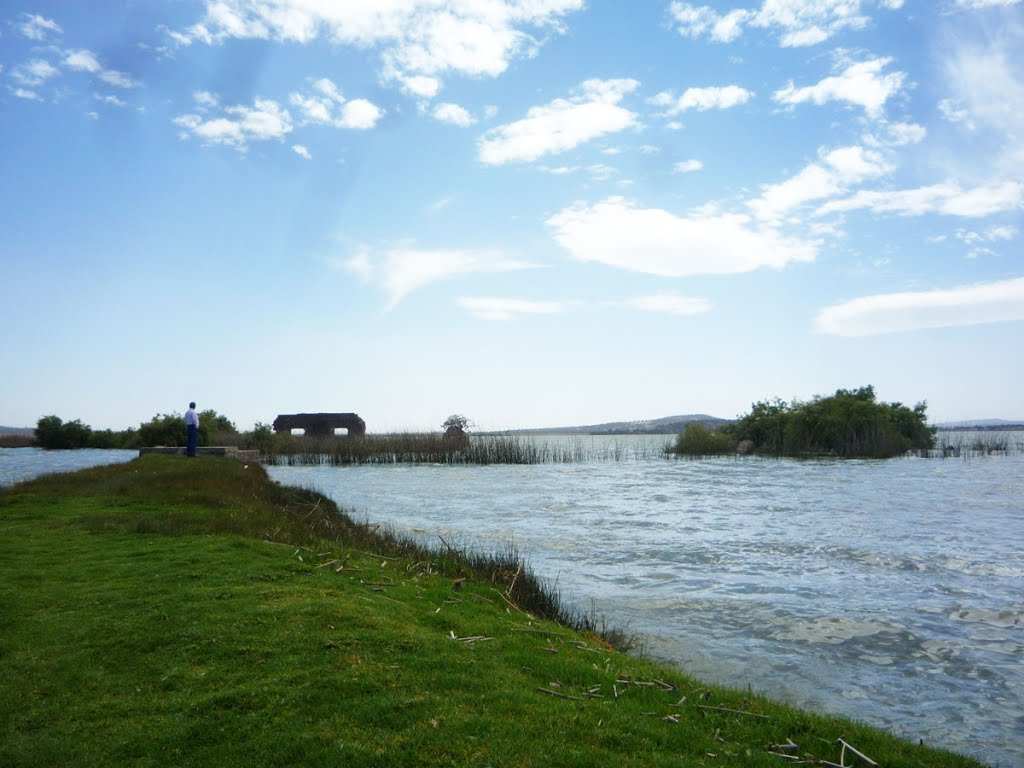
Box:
left=270, top=438, right=1024, bottom=767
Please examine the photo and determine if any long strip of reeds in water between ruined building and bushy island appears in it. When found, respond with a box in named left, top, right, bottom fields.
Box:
left=267, top=433, right=666, bottom=466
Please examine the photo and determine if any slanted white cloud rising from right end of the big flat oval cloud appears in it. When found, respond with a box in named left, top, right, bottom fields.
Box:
left=748, top=146, right=892, bottom=224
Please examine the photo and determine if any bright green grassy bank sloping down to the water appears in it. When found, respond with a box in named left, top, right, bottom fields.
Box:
left=0, top=456, right=991, bottom=768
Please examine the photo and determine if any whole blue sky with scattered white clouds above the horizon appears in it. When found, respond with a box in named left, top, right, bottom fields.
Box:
left=0, top=0, right=1024, bottom=432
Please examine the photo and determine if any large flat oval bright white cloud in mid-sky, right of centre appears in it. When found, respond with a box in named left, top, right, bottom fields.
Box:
left=546, top=198, right=817, bottom=278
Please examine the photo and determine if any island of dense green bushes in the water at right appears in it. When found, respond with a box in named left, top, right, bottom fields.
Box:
left=675, top=386, right=935, bottom=459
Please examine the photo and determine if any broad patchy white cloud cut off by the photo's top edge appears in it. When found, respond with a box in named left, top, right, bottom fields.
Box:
left=172, top=0, right=584, bottom=98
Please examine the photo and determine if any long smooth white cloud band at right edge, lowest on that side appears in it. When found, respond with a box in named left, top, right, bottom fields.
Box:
left=814, top=278, right=1024, bottom=336
